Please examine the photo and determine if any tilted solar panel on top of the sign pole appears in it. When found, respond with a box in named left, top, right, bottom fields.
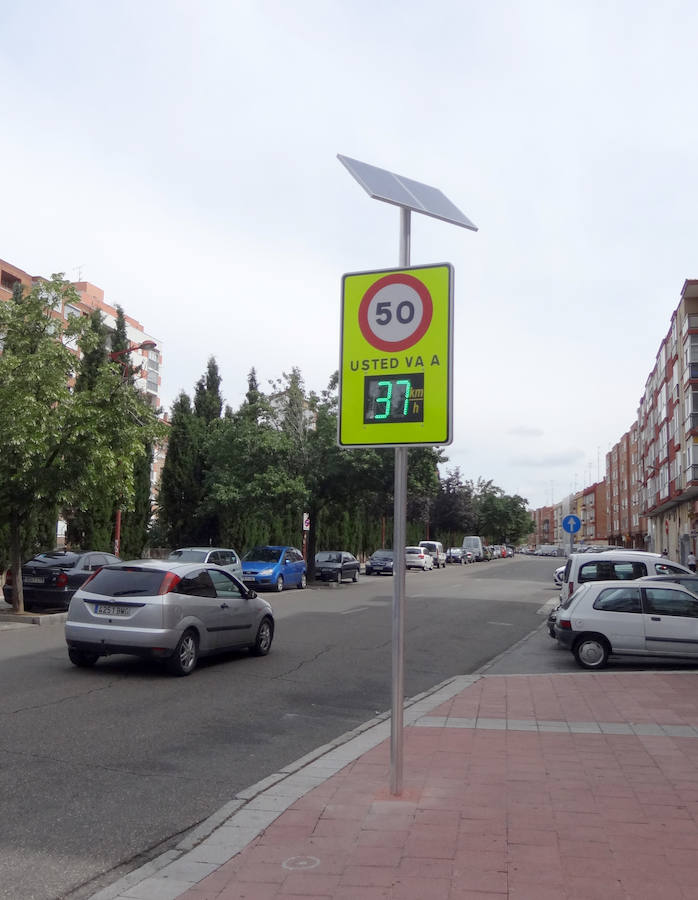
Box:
left=337, top=153, right=477, bottom=231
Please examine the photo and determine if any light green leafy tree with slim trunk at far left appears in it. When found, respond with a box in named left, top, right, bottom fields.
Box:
left=0, top=275, right=159, bottom=612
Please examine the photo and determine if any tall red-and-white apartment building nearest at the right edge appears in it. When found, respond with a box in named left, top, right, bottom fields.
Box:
left=637, top=279, right=698, bottom=562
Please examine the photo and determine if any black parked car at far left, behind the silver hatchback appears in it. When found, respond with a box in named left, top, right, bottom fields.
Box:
left=2, top=550, right=120, bottom=609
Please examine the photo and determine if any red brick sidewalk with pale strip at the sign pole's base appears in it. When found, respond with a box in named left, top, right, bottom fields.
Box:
left=163, top=672, right=698, bottom=900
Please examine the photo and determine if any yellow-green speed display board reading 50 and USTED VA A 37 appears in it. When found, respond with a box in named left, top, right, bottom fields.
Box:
left=338, top=263, right=453, bottom=447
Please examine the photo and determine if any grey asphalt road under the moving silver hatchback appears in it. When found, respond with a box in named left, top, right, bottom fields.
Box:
left=0, top=557, right=556, bottom=900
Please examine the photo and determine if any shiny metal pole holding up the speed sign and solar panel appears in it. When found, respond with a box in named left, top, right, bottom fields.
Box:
left=390, top=206, right=410, bottom=795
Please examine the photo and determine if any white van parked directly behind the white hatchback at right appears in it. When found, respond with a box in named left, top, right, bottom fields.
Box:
left=560, top=550, right=690, bottom=603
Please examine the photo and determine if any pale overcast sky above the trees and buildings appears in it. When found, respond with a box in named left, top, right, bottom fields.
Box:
left=0, top=0, right=698, bottom=507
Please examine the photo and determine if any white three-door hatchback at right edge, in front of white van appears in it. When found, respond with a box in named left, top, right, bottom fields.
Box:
left=554, top=579, right=698, bottom=669
